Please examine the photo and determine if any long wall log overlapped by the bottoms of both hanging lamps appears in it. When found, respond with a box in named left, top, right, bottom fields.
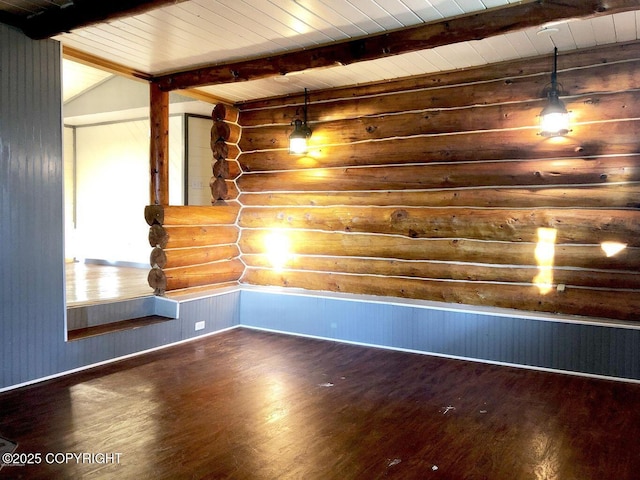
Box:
left=238, top=120, right=640, bottom=172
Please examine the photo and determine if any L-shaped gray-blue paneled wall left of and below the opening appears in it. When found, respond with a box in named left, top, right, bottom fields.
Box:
left=0, top=24, right=240, bottom=390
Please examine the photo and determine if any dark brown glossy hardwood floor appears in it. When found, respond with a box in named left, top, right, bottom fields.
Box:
left=0, top=329, right=640, bottom=480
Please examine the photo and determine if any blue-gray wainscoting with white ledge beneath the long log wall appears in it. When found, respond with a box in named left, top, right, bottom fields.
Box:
left=240, top=288, right=640, bottom=380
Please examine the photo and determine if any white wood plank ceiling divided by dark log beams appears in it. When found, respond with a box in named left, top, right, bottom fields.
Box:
left=0, top=0, right=640, bottom=102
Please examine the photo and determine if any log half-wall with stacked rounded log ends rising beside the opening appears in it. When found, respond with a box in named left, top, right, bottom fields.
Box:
left=145, top=104, right=244, bottom=295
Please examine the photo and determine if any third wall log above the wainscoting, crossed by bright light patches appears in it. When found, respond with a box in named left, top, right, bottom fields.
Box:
left=238, top=229, right=640, bottom=272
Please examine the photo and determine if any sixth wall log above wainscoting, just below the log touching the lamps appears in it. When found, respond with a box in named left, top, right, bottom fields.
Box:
left=237, top=156, right=640, bottom=193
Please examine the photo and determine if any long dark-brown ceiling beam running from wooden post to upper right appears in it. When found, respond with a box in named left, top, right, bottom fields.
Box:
left=152, top=0, right=638, bottom=91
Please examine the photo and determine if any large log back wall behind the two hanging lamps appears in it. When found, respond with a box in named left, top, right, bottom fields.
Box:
left=232, top=42, right=640, bottom=320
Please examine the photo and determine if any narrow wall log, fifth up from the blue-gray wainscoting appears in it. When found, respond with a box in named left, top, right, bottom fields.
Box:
left=239, top=182, right=640, bottom=209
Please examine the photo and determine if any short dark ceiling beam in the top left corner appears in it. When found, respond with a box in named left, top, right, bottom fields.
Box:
left=14, top=0, right=186, bottom=40
